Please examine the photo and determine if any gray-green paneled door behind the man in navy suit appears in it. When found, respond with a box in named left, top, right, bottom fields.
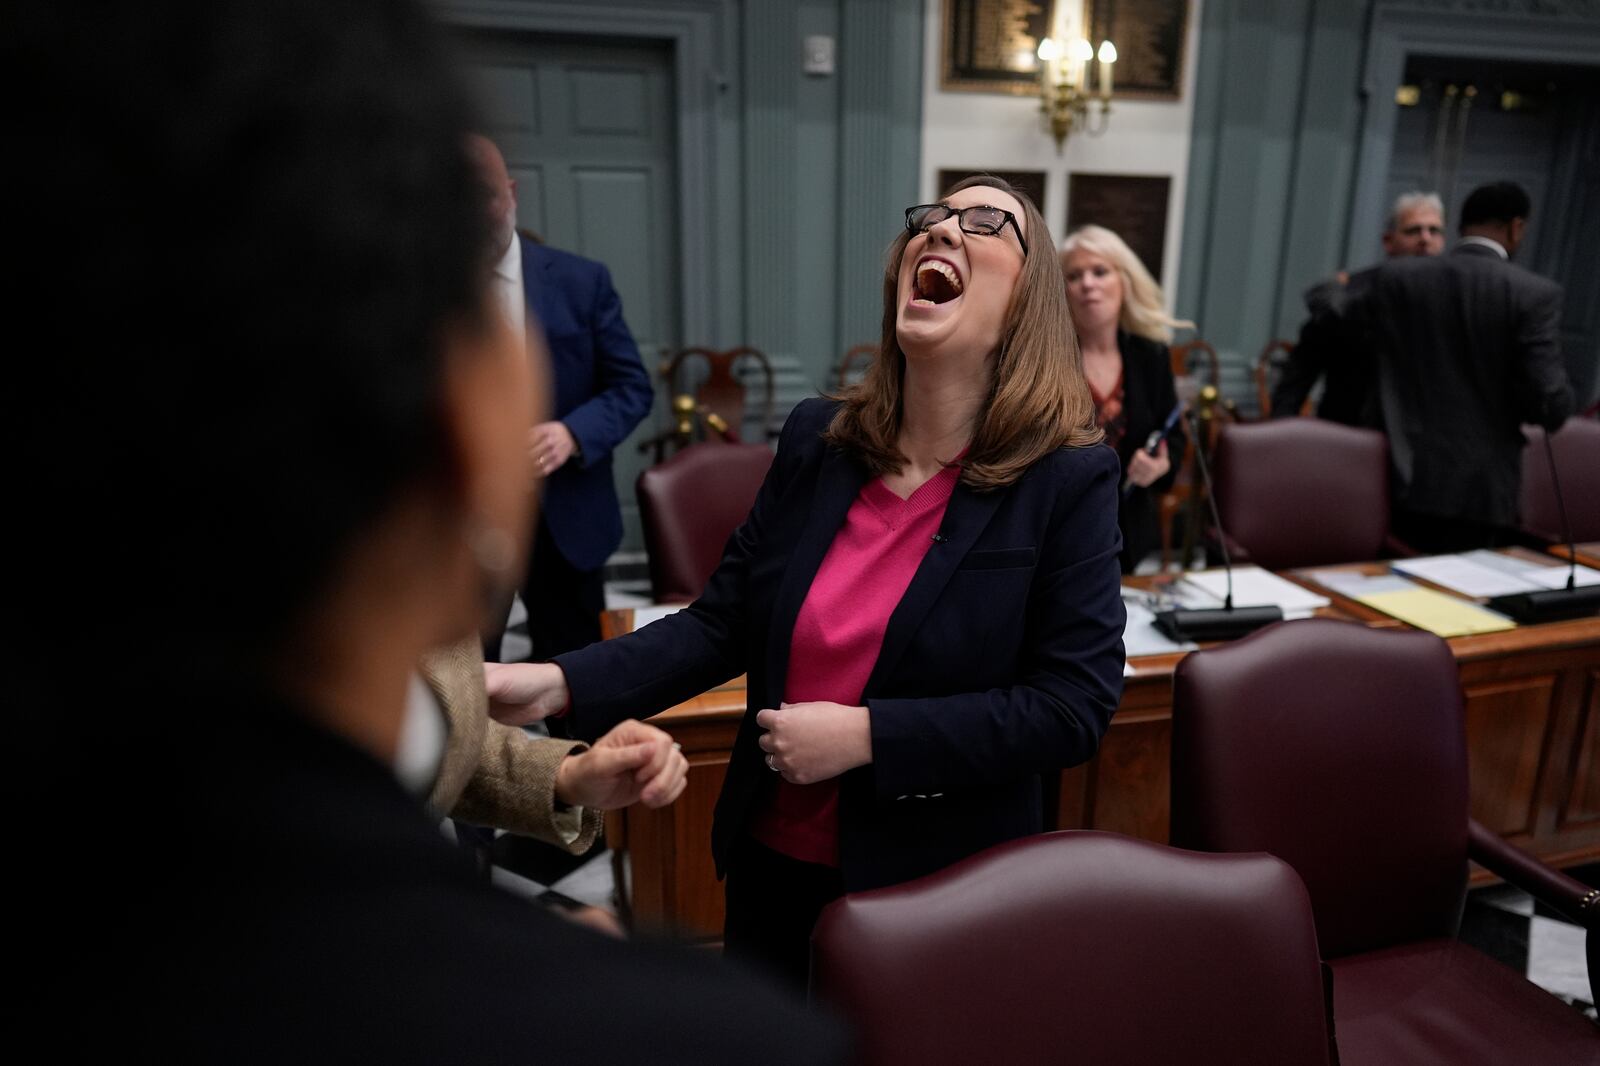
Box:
left=462, top=32, right=682, bottom=551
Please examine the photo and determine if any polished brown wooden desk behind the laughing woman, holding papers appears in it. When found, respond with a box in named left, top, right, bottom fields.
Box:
left=605, top=552, right=1600, bottom=938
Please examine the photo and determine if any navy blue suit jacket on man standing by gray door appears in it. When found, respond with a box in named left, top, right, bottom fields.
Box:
left=517, top=234, right=654, bottom=570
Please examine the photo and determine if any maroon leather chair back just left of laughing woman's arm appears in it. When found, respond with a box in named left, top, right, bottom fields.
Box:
left=635, top=442, right=773, bottom=603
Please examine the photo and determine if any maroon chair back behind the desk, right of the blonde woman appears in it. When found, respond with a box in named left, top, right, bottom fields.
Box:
left=1213, top=418, right=1398, bottom=570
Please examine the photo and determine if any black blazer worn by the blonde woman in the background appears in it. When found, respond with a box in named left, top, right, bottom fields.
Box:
left=1117, top=330, right=1184, bottom=573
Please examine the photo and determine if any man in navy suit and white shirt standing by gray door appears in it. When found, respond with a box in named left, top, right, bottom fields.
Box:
left=470, top=136, right=653, bottom=661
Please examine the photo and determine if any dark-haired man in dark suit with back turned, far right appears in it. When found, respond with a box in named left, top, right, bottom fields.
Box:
left=1347, top=181, right=1573, bottom=552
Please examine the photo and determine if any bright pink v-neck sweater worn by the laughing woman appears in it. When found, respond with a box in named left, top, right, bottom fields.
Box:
left=752, top=466, right=960, bottom=866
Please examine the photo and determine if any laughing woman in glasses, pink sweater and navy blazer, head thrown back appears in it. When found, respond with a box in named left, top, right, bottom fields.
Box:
left=490, top=178, right=1123, bottom=983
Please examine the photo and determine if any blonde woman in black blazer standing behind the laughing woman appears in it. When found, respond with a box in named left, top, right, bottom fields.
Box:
left=1061, top=226, right=1194, bottom=573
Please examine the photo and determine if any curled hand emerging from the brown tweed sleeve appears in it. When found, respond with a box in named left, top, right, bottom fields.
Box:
left=555, top=719, right=690, bottom=810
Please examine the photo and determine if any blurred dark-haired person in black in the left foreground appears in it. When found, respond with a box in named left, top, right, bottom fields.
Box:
left=0, top=0, right=838, bottom=1064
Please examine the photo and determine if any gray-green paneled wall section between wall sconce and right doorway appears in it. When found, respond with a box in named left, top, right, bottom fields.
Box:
left=1178, top=0, right=1365, bottom=410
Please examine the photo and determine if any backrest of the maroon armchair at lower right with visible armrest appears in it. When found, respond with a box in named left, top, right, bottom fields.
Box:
left=1171, top=618, right=1467, bottom=959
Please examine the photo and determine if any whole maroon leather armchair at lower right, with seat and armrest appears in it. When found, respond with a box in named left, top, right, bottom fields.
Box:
left=1171, top=618, right=1600, bottom=1066
